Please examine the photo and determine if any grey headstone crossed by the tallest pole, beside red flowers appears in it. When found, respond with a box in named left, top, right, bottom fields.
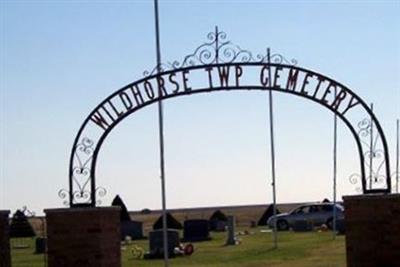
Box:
left=149, top=229, right=179, bottom=257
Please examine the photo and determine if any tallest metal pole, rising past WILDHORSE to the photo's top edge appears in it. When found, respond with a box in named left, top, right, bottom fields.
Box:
left=154, top=0, right=169, bottom=267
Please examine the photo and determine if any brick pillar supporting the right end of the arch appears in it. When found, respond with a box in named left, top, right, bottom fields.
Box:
left=343, top=194, right=400, bottom=267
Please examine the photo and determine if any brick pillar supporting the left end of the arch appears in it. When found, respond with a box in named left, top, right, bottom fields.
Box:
left=44, top=207, right=121, bottom=267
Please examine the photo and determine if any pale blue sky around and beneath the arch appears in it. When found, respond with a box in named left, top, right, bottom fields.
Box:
left=0, top=1, right=400, bottom=213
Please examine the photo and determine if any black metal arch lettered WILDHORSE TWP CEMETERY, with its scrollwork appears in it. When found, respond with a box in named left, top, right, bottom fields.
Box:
left=59, top=31, right=391, bottom=207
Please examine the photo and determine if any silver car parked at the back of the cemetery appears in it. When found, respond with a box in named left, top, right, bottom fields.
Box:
left=267, top=203, right=344, bottom=231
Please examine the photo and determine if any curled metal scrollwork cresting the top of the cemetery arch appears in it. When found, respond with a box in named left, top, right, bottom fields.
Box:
left=143, top=27, right=297, bottom=77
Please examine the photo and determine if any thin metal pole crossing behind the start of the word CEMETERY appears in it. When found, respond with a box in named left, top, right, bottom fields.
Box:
left=267, top=48, right=278, bottom=248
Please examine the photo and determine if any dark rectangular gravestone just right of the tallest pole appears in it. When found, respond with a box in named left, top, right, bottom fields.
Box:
left=183, top=220, right=210, bottom=242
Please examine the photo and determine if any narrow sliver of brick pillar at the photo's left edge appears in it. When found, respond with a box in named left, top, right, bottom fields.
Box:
left=0, top=210, right=11, bottom=267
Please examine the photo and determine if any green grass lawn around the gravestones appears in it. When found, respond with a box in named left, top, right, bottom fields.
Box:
left=12, top=231, right=346, bottom=267
